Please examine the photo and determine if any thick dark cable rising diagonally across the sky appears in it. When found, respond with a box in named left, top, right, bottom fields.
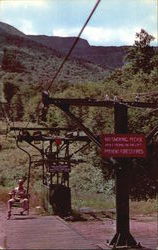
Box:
left=46, top=0, right=101, bottom=91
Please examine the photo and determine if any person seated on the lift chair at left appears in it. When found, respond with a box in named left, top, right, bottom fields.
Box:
left=8, top=180, right=29, bottom=219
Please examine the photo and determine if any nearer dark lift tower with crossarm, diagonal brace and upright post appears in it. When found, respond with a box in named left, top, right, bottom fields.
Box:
left=42, top=92, right=158, bottom=247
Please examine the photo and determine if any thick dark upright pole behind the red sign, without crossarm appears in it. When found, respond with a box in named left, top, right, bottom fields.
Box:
left=110, top=104, right=137, bottom=247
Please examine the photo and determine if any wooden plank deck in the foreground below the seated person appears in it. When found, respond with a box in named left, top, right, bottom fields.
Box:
left=5, top=216, right=101, bottom=250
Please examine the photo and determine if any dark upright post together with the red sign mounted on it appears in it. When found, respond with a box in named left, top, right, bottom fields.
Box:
left=104, top=104, right=144, bottom=247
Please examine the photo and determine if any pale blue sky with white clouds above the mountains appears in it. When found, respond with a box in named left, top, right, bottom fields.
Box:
left=0, top=0, right=158, bottom=46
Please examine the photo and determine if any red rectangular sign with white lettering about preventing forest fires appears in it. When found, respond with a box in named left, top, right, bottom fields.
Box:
left=102, top=134, right=146, bottom=158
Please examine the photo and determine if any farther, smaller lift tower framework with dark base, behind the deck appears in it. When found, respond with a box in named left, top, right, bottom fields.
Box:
left=8, top=127, right=90, bottom=215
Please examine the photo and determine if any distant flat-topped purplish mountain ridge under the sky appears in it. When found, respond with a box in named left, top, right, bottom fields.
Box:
left=28, top=35, right=128, bottom=69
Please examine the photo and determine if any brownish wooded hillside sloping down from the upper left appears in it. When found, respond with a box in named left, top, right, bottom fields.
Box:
left=0, top=22, right=108, bottom=88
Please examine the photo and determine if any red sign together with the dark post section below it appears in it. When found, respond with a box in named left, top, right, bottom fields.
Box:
left=102, top=133, right=146, bottom=246
